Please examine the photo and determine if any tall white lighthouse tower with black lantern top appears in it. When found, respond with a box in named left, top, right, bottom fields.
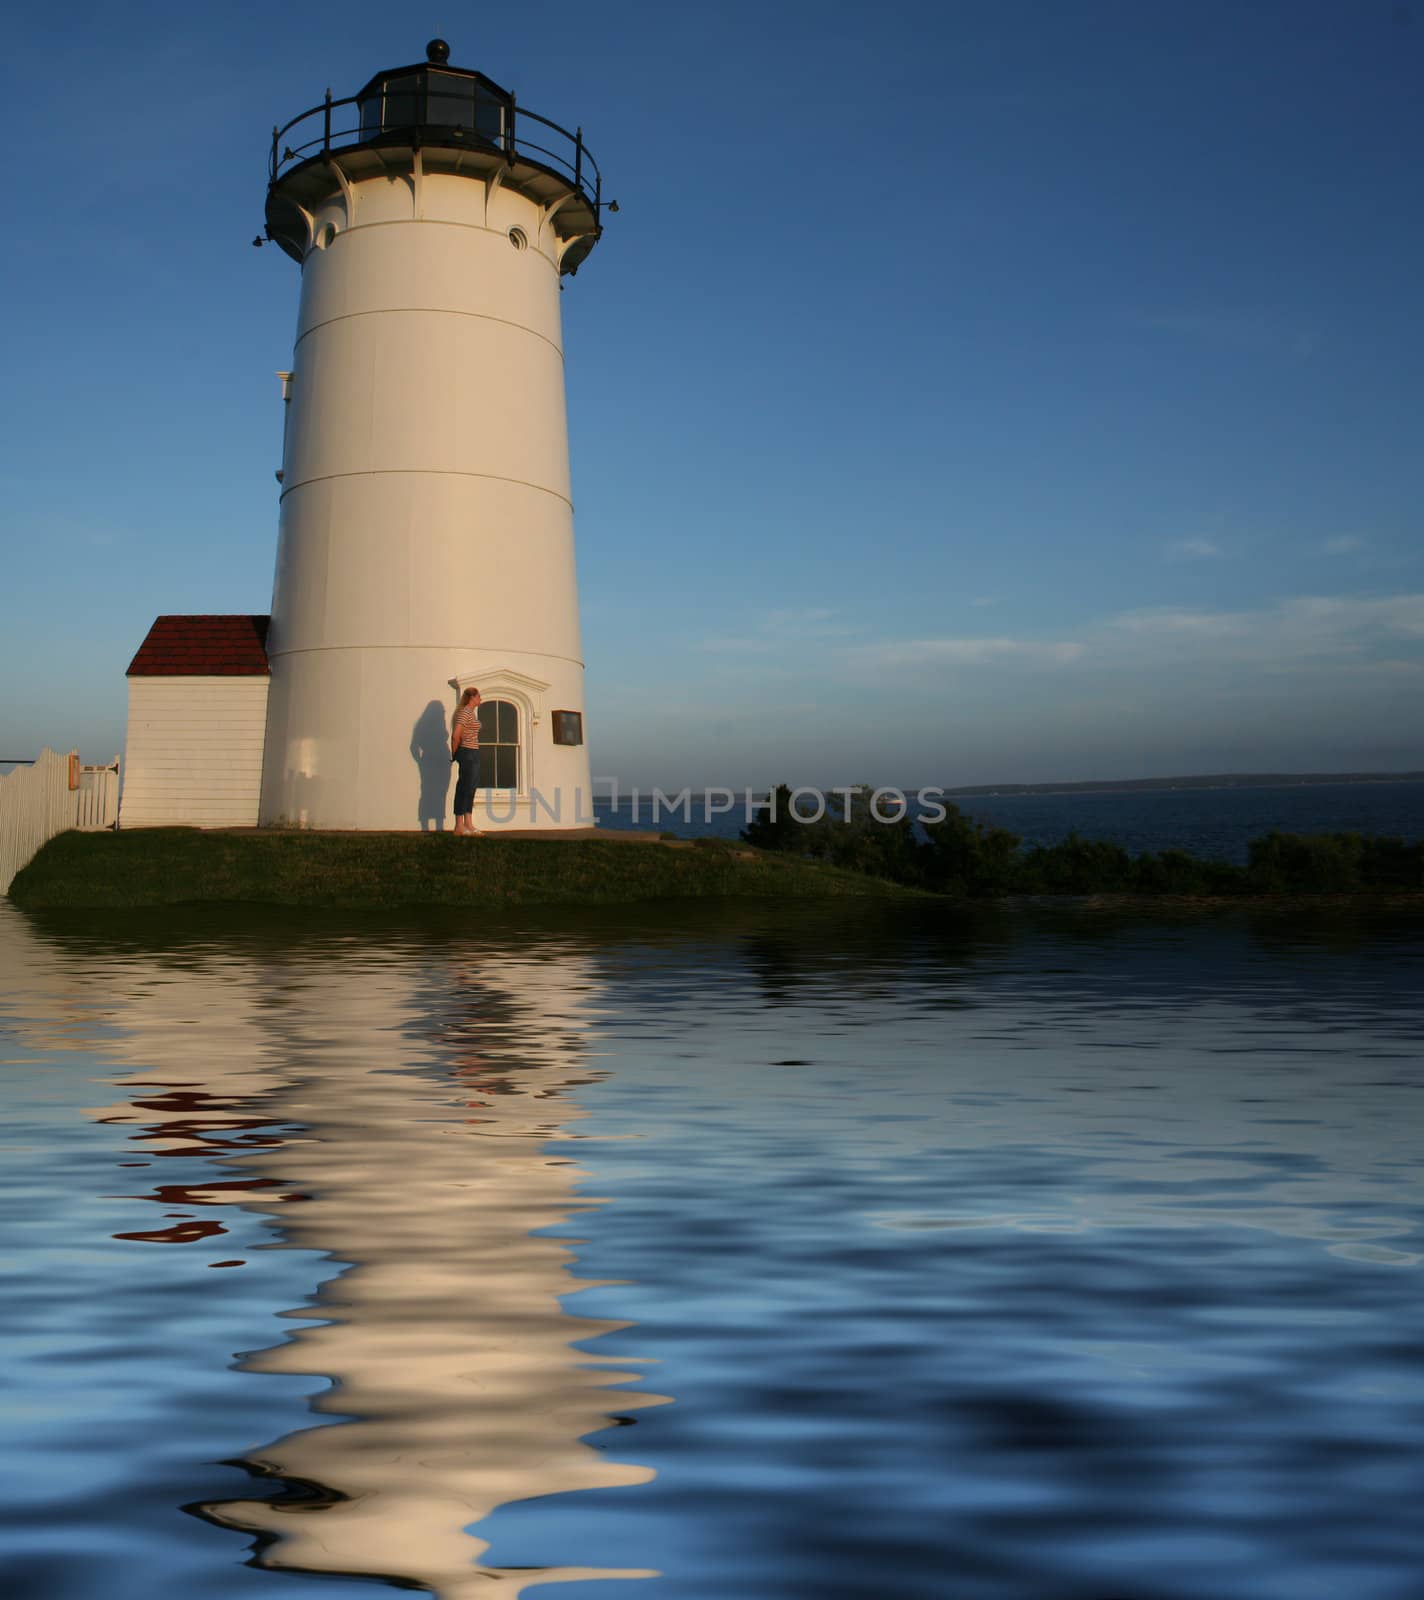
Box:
left=261, top=40, right=602, bottom=829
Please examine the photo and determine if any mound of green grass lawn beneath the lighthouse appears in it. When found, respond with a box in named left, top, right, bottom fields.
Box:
left=10, top=827, right=920, bottom=909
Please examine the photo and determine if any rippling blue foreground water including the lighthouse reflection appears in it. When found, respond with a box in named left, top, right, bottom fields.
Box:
left=0, top=904, right=1424, bottom=1600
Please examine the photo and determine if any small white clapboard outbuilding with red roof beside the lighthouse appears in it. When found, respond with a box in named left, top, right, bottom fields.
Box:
left=118, top=616, right=270, bottom=827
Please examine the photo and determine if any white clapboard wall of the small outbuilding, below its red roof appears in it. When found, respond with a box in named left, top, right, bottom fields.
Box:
left=118, top=675, right=269, bottom=827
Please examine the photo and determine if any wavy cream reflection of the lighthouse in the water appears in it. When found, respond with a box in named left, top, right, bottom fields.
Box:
left=48, top=944, right=656, bottom=1600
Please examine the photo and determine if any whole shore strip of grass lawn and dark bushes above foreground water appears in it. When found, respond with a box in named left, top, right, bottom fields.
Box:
left=10, top=808, right=1424, bottom=909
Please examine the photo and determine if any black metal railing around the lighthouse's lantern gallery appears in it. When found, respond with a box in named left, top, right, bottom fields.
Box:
left=267, top=79, right=603, bottom=222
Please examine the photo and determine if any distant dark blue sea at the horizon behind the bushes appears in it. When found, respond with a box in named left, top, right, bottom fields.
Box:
left=595, top=782, right=1424, bottom=864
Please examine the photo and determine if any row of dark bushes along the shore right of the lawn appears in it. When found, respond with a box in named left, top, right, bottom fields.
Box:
left=742, top=784, right=1424, bottom=899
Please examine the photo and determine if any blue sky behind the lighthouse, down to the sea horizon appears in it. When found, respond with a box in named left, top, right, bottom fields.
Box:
left=0, top=0, right=1424, bottom=784
